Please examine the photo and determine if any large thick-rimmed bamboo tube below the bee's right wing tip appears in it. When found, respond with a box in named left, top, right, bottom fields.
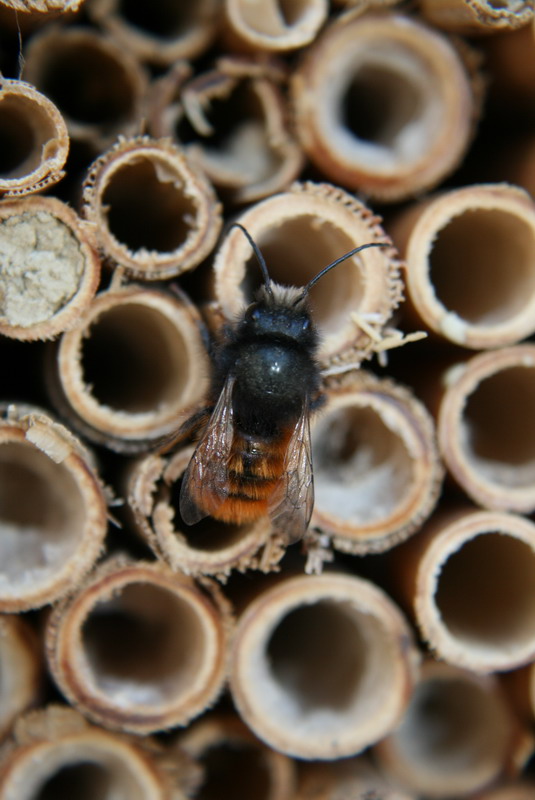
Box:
left=230, top=574, right=416, bottom=759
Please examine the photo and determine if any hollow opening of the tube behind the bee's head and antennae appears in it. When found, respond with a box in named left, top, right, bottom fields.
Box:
left=241, top=219, right=364, bottom=334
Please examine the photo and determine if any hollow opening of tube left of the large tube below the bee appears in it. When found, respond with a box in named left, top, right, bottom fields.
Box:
left=82, top=583, right=205, bottom=707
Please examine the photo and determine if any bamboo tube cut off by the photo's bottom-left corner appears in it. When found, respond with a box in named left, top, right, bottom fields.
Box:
left=0, top=706, right=180, bottom=800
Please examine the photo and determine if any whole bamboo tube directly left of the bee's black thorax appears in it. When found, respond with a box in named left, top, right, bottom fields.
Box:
left=48, top=284, right=210, bottom=452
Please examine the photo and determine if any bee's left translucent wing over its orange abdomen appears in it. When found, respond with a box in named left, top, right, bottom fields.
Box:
left=180, top=378, right=234, bottom=525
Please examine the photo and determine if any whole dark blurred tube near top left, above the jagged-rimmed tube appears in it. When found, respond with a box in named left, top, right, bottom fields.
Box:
left=24, top=26, right=148, bottom=152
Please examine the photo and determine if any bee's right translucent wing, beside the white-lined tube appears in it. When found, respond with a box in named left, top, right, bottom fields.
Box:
left=269, top=405, right=314, bottom=544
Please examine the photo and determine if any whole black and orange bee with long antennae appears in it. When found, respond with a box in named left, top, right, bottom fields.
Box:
left=180, top=222, right=389, bottom=543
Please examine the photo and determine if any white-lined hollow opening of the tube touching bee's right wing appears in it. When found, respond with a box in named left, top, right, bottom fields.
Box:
left=312, top=407, right=413, bottom=524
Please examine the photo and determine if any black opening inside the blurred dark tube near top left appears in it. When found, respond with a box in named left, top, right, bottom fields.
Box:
left=35, top=37, right=135, bottom=125
